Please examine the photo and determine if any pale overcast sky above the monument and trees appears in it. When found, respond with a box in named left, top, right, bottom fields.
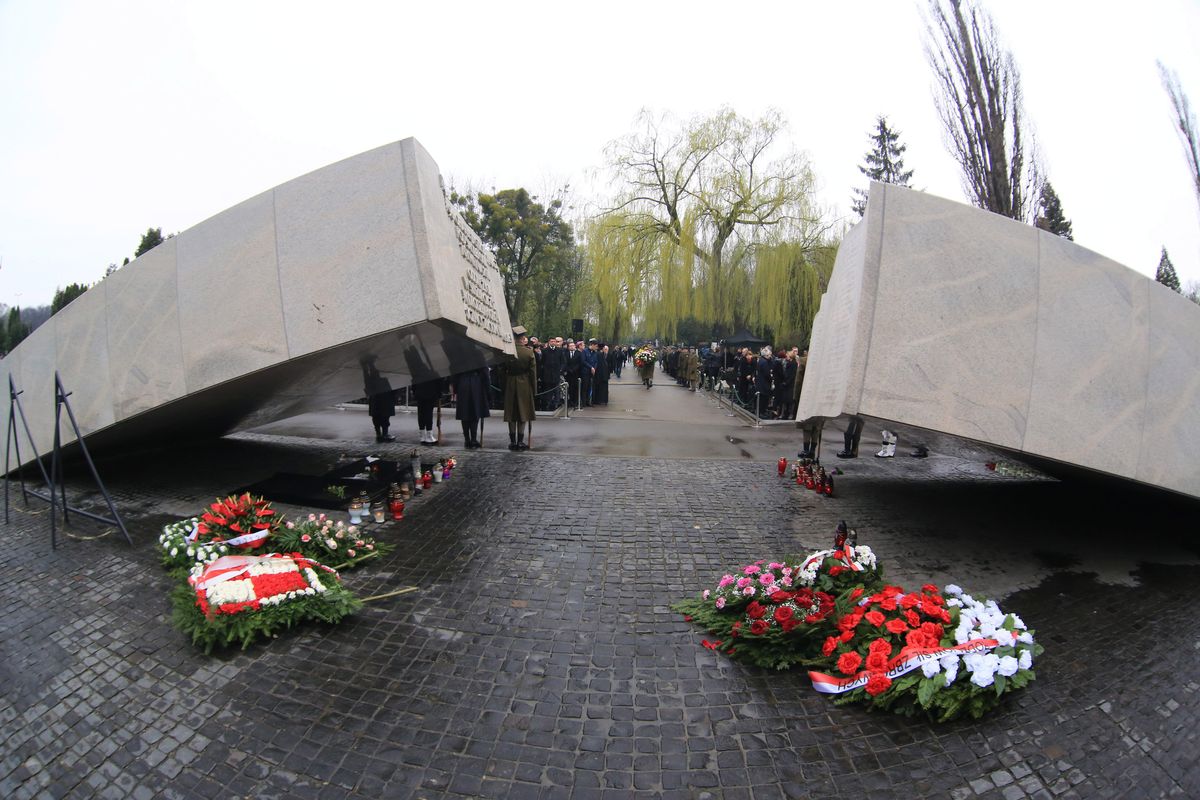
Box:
left=0, top=0, right=1200, bottom=306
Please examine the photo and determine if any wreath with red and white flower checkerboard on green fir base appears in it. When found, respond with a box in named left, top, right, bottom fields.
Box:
left=172, top=553, right=362, bottom=652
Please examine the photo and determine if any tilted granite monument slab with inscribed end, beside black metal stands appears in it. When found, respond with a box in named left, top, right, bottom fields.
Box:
left=0, top=139, right=515, bottom=461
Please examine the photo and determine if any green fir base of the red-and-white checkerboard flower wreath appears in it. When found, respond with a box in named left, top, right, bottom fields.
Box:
left=170, top=583, right=362, bottom=655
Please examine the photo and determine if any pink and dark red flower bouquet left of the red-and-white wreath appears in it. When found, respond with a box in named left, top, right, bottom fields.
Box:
left=672, top=560, right=834, bottom=669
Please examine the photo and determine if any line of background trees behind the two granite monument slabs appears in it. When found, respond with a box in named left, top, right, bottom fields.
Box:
left=0, top=0, right=1200, bottom=351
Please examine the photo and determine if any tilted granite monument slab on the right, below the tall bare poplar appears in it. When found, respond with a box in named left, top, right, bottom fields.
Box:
left=797, top=184, right=1200, bottom=497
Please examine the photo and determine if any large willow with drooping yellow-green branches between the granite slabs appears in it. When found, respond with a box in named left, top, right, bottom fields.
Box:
left=589, top=108, right=827, bottom=336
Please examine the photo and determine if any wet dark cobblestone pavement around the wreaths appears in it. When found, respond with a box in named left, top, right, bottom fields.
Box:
left=0, top=387, right=1200, bottom=800
